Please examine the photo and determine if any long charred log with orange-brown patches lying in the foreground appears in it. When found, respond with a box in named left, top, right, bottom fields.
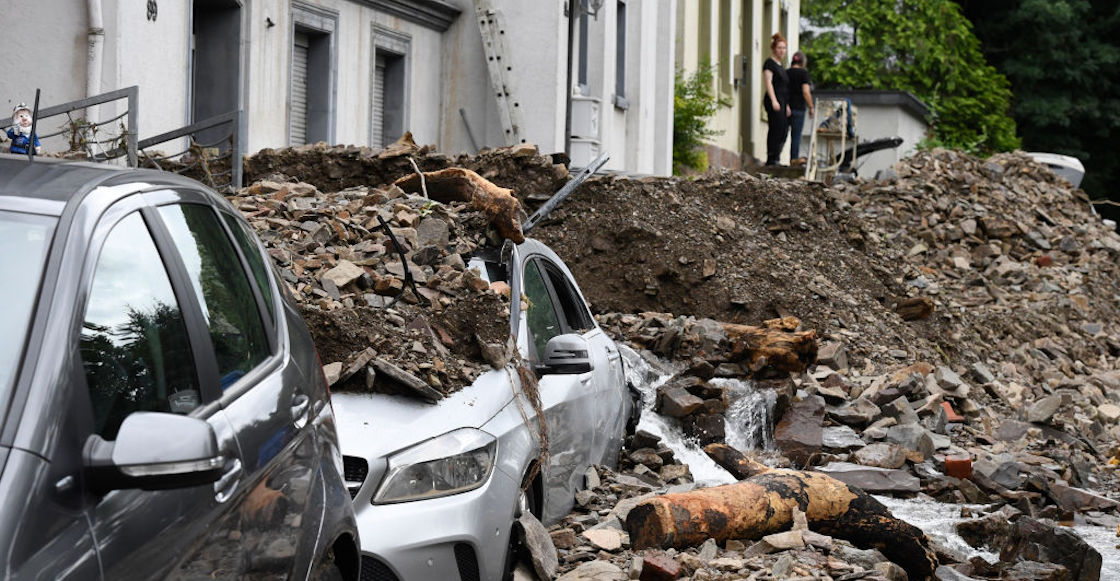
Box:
left=626, top=470, right=937, bottom=580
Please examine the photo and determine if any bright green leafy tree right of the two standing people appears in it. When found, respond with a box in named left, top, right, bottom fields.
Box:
left=802, top=0, right=1019, bottom=153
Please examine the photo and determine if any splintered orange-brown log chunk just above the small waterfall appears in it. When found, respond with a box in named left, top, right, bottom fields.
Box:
left=724, top=317, right=818, bottom=377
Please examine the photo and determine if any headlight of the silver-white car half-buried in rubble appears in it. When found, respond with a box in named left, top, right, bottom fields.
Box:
left=373, top=428, right=497, bottom=504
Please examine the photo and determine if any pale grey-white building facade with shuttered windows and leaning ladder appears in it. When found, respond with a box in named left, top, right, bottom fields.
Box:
left=0, top=0, right=678, bottom=174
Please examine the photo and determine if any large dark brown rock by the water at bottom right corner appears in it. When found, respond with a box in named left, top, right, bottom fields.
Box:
left=999, top=516, right=1101, bottom=581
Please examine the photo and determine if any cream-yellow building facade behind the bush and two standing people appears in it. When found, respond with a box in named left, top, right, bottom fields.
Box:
left=675, top=0, right=801, bottom=169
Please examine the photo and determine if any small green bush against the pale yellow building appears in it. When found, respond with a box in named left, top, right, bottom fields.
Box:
left=673, top=63, right=725, bottom=174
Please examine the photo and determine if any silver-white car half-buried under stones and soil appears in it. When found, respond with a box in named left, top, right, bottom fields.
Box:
left=333, top=240, right=635, bottom=581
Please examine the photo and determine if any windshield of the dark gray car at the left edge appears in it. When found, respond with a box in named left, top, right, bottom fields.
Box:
left=0, top=210, right=55, bottom=401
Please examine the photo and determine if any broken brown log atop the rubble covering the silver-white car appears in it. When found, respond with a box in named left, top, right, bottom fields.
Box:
left=393, top=168, right=525, bottom=244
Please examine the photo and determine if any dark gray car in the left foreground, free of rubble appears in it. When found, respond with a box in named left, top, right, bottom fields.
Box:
left=0, top=154, right=360, bottom=580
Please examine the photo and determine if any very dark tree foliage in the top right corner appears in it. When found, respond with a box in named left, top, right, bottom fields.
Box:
left=959, top=0, right=1120, bottom=220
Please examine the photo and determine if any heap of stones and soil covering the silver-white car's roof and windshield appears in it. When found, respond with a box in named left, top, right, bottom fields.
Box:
left=228, top=170, right=513, bottom=400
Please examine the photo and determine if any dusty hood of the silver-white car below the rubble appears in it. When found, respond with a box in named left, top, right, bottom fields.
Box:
left=330, top=369, right=513, bottom=460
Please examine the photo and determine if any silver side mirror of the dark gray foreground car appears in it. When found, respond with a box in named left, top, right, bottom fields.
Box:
left=83, top=412, right=224, bottom=493
